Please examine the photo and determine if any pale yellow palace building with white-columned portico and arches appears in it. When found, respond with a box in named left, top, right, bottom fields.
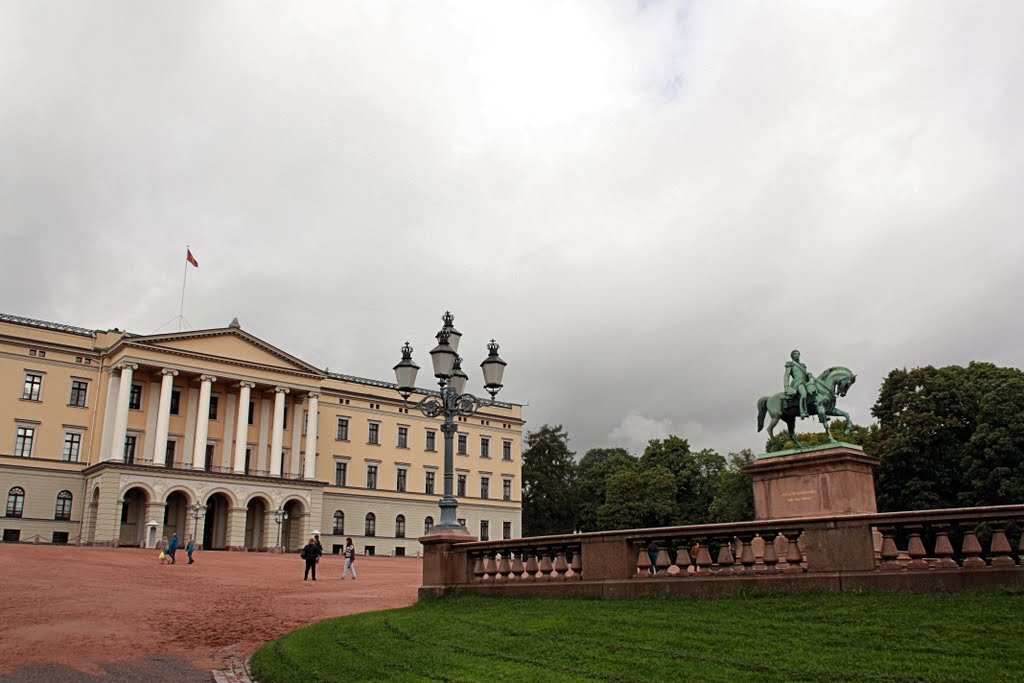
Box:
left=0, top=314, right=523, bottom=555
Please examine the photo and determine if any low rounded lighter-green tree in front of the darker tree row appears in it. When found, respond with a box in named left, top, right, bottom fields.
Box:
left=597, top=465, right=678, bottom=529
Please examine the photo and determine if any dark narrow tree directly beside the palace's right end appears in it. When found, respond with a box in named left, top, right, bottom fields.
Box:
left=522, top=425, right=577, bottom=537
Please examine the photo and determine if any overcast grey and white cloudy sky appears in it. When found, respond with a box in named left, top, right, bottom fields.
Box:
left=0, top=0, right=1024, bottom=455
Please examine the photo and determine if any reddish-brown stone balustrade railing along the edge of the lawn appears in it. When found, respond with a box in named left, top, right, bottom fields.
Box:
left=420, top=505, right=1024, bottom=597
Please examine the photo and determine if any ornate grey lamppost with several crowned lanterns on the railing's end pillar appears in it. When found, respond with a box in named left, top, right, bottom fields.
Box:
left=394, top=311, right=507, bottom=535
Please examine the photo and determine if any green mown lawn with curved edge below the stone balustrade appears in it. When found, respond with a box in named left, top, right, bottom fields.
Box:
left=247, top=592, right=1024, bottom=683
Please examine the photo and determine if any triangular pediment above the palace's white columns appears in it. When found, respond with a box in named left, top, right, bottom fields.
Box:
left=125, top=328, right=324, bottom=375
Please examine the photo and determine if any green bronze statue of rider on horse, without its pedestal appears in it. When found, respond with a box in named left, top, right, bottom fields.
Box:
left=758, top=350, right=857, bottom=449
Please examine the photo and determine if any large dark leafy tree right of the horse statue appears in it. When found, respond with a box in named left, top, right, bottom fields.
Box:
left=864, top=362, right=1024, bottom=510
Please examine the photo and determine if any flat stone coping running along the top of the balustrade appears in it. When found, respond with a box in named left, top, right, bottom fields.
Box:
left=452, top=505, right=1024, bottom=550
